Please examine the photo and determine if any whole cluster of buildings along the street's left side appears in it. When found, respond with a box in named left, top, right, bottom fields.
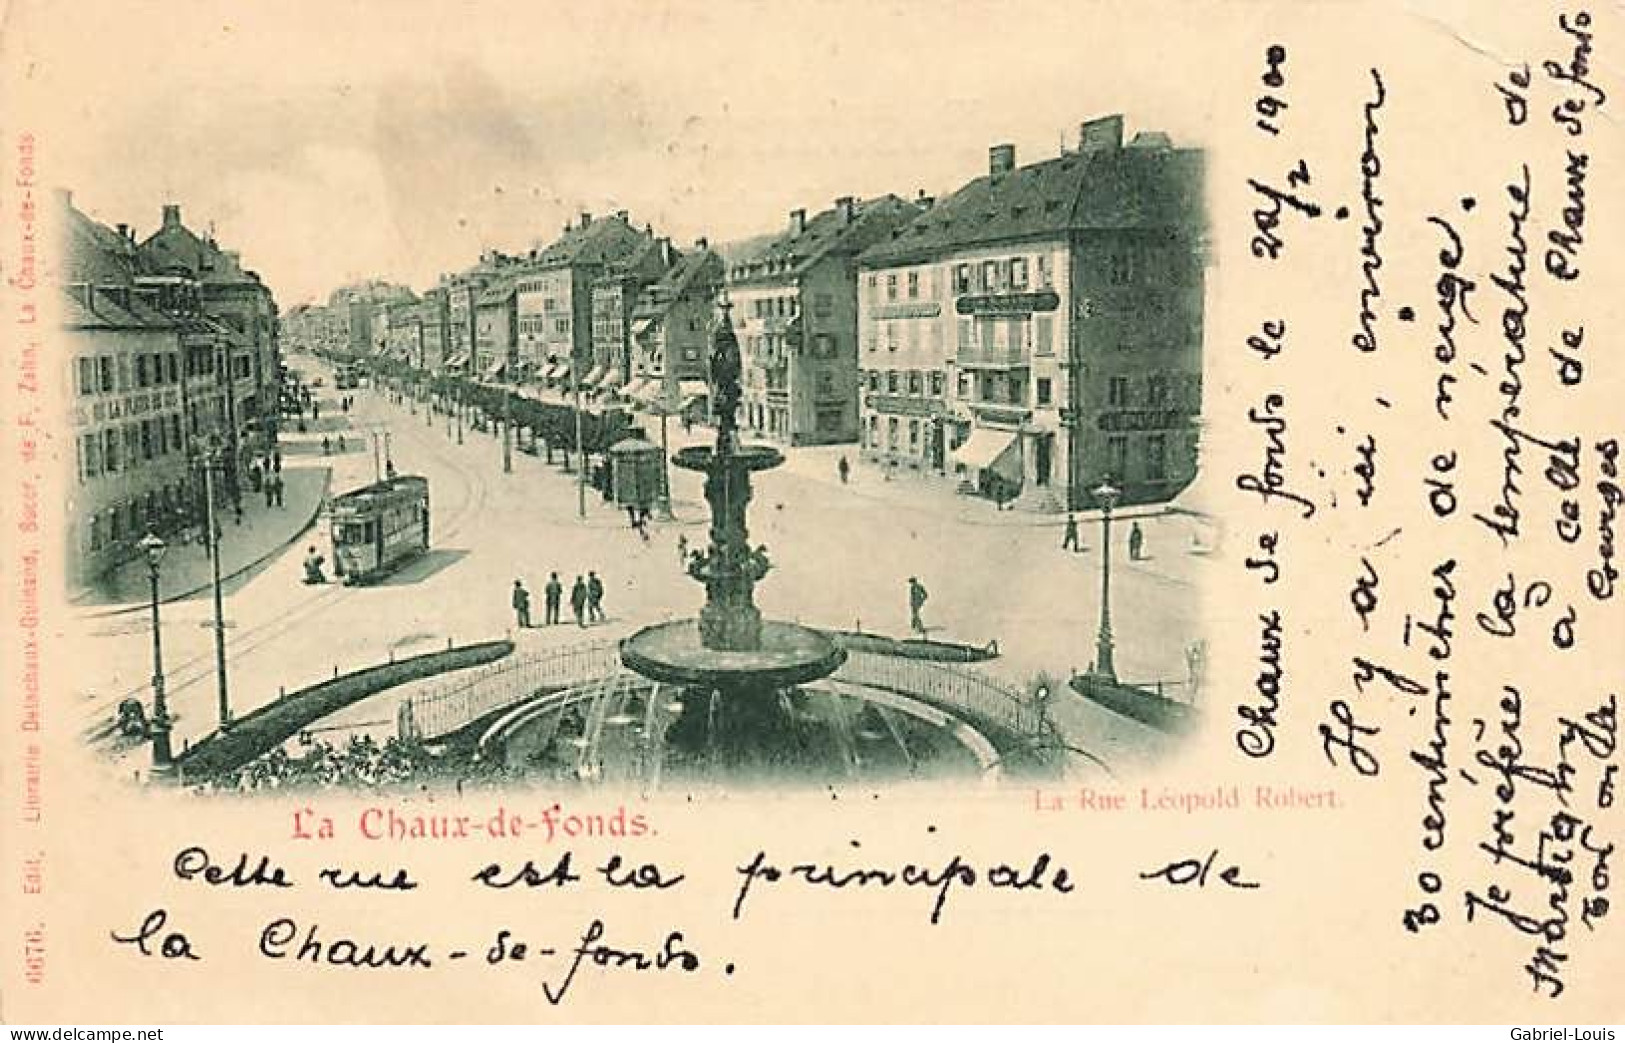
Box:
left=57, top=192, right=281, bottom=582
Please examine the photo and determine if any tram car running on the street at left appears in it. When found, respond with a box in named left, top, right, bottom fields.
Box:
left=332, top=474, right=429, bottom=585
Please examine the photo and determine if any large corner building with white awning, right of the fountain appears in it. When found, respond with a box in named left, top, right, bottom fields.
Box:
left=860, top=117, right=1204, bottom=510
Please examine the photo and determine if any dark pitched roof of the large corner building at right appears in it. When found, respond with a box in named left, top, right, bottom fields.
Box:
left=860, top=135, right=1204, bottom=266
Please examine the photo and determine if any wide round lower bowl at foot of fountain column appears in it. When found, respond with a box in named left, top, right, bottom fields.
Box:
left=621, top=619, right=847, bottom=685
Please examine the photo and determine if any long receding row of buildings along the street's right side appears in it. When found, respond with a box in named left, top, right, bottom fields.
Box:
left=288, top=115, right=1206, bottom=510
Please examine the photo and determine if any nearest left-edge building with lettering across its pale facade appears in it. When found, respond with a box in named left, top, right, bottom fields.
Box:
left=62, top=193, right=252, bottom=582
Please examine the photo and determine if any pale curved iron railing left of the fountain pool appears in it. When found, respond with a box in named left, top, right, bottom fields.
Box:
left=400, top=642, right=622, bottom=739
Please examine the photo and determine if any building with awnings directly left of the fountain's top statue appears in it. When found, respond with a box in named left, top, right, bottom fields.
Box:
left=626, top=239, right=723, bottom=414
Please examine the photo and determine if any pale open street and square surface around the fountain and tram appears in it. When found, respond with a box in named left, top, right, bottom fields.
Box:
left=78, top=359, right=1206, bottom=770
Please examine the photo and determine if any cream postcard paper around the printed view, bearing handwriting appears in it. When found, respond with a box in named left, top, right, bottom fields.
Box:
left=0, top=2, right=1625, bottom=1024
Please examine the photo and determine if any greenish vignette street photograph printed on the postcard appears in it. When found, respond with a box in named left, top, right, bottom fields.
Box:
left=50, top=8, right=1222, bottom=794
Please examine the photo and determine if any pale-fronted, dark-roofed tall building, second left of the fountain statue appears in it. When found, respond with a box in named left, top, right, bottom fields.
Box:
left=514, top=211, right=653, bottom=388
